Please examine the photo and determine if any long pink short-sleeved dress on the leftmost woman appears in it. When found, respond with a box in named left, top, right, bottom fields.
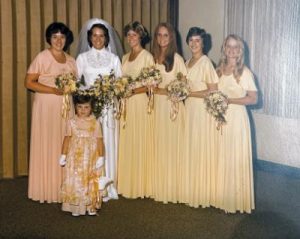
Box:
left=27, top=49, right=77, bottom=203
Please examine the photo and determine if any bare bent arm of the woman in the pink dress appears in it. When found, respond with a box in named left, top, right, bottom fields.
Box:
left=24, top=74, right=63, bottom=95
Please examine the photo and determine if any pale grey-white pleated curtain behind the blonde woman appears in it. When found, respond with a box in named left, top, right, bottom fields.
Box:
left=225, top=0, right=300, bottom=119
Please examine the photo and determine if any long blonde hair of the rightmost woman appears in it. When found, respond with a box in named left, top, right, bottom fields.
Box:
left=216, top=34, right=244, bottom=82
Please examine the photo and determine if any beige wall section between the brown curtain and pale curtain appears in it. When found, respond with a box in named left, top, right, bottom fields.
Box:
left=178, top=0, right=224, bottom=63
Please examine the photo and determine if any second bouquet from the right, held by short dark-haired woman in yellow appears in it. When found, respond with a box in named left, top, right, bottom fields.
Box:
left=166, top=72, right=191, bottom=121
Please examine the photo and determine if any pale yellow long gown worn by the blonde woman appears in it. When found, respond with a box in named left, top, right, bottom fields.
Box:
left=216, top=67, right=257, bottom=213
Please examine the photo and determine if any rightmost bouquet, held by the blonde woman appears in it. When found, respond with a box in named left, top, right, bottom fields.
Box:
left=204, top=91, right=228, bottom=130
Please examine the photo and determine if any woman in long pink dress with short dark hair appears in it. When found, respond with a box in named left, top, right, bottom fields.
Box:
left=25, top=22, right=77, bottom=203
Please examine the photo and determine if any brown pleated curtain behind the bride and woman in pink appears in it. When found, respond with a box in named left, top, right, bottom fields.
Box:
left=0, top=0, right=178, bottom=178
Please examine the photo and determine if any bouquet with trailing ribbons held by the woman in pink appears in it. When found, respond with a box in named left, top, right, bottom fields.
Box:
left=55, top=72, right=77, bottom=119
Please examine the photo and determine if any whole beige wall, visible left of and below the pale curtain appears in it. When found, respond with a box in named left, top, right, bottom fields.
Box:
left=178, top=0, right=300, bottom=168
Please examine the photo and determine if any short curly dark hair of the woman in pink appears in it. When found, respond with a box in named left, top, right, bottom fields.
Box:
left=45, top=22, right=74, bottom=51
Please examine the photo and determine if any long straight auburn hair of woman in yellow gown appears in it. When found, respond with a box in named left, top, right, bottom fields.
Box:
left=152, top=22, right=177, bottom=72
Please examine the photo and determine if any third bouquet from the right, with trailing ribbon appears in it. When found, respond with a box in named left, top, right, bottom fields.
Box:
left=137, top=66, right=162, bottom=114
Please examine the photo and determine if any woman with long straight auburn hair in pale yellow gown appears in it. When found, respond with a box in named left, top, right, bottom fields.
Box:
left=153, top=23, right=187, bottom=203
